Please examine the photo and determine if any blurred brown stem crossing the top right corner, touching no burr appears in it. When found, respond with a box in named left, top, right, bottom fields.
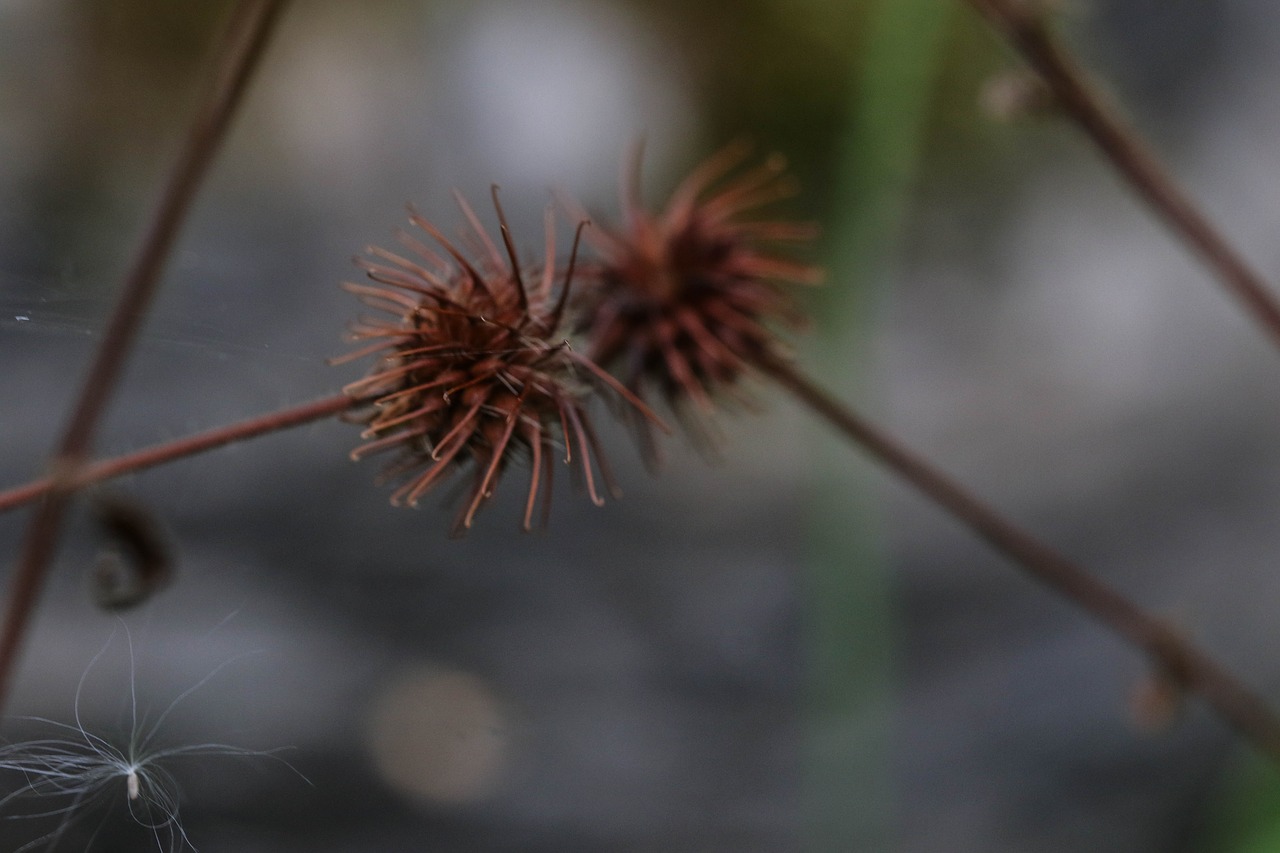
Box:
left=969, top=0, right=1280, bottom=346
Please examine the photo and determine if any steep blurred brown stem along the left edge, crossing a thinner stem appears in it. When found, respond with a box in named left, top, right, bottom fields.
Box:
left=0, top=0, right=285, bottom=707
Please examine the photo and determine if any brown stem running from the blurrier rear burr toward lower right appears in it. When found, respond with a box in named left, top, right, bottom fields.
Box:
left=760, top=350, right=1280, bottom=761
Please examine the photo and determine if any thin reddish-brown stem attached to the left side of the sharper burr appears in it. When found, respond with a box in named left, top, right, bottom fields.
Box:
left=0, top=394, right=362, bottom=512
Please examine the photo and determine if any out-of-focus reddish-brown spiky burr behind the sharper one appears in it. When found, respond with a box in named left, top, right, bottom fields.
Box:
left=577, top=145, right=820, bottom=448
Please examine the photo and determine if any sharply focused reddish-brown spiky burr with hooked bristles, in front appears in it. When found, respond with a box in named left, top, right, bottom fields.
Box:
left=337, top=188, right=657, bottom=535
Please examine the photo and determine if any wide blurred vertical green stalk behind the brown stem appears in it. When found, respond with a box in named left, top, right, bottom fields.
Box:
left=804, top=0, right=952, bottom=852
